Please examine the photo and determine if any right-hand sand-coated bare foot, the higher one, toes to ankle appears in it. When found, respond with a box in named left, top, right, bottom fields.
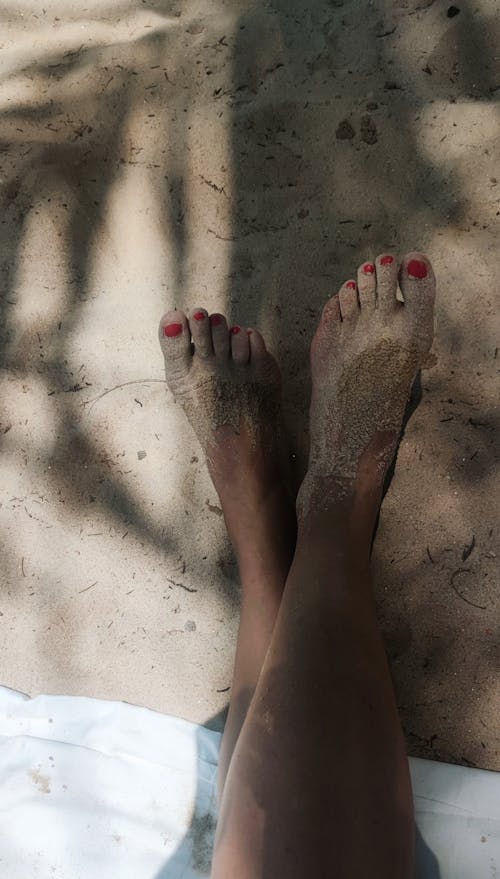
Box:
left=297, top=253, right=435, bottom=518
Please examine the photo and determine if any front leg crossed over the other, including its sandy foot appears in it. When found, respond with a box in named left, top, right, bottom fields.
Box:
left=212, top=254, right=434, bottom=879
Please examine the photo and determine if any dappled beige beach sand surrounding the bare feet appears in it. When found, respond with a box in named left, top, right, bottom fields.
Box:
left=0, top=0, right=500, bottom=769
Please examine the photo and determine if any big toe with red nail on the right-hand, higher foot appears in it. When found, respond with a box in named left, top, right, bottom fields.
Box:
left=399, top=251, right=436, bottom=339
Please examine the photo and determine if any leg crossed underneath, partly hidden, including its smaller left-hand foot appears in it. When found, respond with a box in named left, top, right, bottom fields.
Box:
left=159, top=308, right=296, bottom=794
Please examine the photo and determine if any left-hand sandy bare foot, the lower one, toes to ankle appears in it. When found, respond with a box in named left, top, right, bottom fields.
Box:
left=159, top=308, right=281, bottom=490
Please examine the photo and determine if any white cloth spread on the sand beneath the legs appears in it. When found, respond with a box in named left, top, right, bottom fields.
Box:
left=0, top=687, right=500, bottom=879
